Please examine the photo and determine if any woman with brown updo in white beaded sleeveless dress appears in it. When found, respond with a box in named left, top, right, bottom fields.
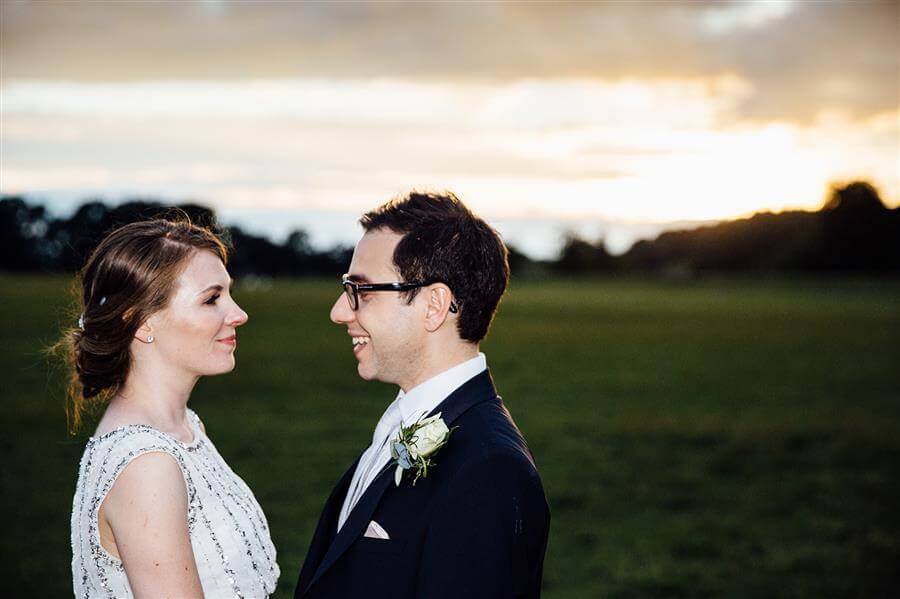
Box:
left=58, top=220, right=280, bottom=597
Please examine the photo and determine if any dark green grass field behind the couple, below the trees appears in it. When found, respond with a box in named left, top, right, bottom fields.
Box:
left=0, top=276, right=900, bottom=598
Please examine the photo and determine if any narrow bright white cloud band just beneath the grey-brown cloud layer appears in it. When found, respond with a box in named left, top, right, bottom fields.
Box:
left=0, top=77, right=747, bottom=128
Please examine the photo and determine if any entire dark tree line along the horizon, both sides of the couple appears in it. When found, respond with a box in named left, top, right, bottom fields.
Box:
left=0, top=181, right=900, bottom=277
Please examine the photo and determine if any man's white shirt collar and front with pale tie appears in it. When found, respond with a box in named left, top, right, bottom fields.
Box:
left=338, top=352, right=487, bottom=532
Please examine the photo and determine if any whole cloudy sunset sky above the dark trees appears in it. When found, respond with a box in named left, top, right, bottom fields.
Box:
left=0, top=0, right=900, bottom=254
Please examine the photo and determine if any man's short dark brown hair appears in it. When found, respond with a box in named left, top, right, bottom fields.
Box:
left=359, top=191, right=509, bottom=343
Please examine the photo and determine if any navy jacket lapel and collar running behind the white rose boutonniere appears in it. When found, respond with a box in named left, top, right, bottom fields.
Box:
left=305, top=370, right=497, bottom=590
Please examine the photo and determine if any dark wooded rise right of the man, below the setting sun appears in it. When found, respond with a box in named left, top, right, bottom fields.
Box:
left=554, top=181, right=900, bottom=277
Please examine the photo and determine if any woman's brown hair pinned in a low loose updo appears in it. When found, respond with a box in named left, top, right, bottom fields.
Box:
left=51, top=216, right=228, bottom=434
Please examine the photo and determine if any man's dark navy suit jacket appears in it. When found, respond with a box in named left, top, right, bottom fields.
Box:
left=294, top=372, right=550, bottom=599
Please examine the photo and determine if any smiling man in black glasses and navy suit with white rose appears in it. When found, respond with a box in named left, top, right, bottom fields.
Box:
left=294, top=193, right=550, bottom=599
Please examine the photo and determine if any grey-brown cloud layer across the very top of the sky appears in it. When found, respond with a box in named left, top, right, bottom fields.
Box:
left=0, top=1, right=900, bottom=121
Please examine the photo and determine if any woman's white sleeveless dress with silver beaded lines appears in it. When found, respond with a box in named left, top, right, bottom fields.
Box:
left=72, top=410, right=280, bottom=599
